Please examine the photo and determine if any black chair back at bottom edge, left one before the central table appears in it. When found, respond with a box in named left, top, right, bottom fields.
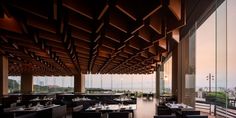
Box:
left=73, top=112, right=102, bottom=118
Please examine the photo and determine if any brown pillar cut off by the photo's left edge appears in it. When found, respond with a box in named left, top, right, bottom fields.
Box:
left=0, top=55, right=8, bottom=95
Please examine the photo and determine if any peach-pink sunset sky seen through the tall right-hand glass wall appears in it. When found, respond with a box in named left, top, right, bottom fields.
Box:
left=196, top=0, right=236, bottom=88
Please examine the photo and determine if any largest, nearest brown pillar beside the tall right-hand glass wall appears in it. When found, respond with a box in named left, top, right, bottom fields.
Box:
left=177, top=35, right=196, bottom=107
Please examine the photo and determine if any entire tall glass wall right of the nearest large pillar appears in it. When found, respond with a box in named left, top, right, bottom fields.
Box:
left=196, top=0, right=236, bottom=117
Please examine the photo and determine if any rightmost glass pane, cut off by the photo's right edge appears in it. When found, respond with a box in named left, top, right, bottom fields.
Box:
left=227, top=0, right=236, bottom=111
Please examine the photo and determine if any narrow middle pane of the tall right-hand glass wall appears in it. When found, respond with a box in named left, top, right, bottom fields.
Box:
left=214, top=1, right=228, bottom=115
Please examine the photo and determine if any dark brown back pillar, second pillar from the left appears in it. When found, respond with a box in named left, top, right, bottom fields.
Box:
left=21, top=72, right=33, bottom=94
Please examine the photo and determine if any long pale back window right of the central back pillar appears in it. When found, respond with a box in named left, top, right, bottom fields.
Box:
left=85, top=73, right=156, bottom=93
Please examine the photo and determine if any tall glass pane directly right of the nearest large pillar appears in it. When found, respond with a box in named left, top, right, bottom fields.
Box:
left=195, top=10, right=216, bottom=113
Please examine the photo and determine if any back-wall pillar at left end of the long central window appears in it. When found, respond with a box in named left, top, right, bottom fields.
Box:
left=74, top=74, right=85, bottom=93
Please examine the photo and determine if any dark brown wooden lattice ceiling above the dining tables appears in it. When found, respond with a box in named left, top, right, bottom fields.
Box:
left=0, top=0, right=185, bottom=75
